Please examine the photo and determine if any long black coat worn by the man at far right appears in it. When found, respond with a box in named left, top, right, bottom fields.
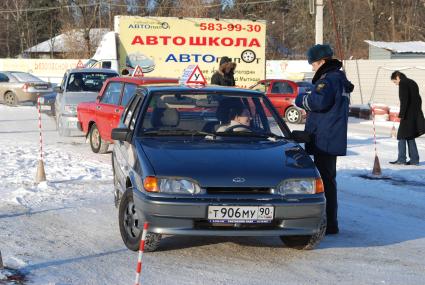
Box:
left=397, top=77, right=425, bottom=140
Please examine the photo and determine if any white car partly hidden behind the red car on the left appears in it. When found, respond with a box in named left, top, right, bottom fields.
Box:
left=55, top=68, right=118, bottom=136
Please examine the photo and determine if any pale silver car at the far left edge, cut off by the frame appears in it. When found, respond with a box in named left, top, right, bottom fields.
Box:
left=0, top=71, right=53, bottom=106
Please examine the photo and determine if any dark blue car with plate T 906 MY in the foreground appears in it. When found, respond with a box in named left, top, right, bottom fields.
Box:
left=112, top=86, right=326, bottom=251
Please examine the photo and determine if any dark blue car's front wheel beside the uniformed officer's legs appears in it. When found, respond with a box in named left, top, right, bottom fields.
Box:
left=280, top=213, right=326, bottom=250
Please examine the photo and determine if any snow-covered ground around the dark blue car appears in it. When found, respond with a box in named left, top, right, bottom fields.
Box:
left=0, top=105, right=425, bottom=285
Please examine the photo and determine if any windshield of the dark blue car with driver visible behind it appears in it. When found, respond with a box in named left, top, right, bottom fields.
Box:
left=138, top=94, right=286, bottom=138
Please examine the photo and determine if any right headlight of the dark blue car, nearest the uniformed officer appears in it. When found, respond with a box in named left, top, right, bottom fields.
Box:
left=278, top=178, right=324, bottom=195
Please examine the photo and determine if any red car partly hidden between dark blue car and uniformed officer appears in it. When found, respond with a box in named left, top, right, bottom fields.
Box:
left=250, top=79, right=306, bottom=124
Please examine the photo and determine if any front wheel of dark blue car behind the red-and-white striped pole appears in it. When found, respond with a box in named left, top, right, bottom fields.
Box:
left=118, top=188, right=161, bottom=252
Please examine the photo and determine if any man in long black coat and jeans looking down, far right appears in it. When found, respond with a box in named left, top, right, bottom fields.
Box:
left=390, top=71, right=425, bottom=165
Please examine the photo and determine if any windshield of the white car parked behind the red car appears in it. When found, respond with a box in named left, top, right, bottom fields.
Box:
left=66, top=72, right=117, bottom=92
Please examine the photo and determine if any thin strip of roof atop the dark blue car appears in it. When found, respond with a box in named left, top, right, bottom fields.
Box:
left=137, top=84, right=264, bottom=96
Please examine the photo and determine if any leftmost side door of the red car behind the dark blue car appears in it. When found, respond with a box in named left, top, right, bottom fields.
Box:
left=95, top=81, right=123, bottom=140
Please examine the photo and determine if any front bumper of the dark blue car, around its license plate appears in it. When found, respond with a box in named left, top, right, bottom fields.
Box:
left=133, top=190, right=326, bottom=236
